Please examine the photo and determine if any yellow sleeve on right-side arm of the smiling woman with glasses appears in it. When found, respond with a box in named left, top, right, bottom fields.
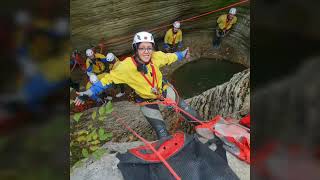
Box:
left=152, top=51, right=178, bottom=68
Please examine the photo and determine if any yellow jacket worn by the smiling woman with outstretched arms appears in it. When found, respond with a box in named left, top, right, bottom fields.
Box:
left=101, top=51, right=178, bottom=99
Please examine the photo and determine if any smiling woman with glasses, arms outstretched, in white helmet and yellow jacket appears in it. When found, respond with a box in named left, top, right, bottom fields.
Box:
left=75, top=32, right=200, bottom=139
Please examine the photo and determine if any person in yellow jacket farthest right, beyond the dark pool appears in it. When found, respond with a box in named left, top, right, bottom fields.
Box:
left=213, top=8, right=237, bottom=48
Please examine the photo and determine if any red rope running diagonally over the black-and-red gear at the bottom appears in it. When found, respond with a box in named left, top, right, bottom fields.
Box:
left=113, top=113, right=181, bottom=180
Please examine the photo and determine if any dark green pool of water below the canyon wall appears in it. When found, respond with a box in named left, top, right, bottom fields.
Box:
left=169, top=59, right=246, bottom=98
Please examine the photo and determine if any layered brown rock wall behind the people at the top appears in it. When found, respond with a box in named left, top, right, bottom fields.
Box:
left=70, top=0, right=250, bottom=66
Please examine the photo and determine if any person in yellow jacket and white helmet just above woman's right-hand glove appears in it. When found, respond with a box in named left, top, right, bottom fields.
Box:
left=164, top=21, right=182, bottom=52
